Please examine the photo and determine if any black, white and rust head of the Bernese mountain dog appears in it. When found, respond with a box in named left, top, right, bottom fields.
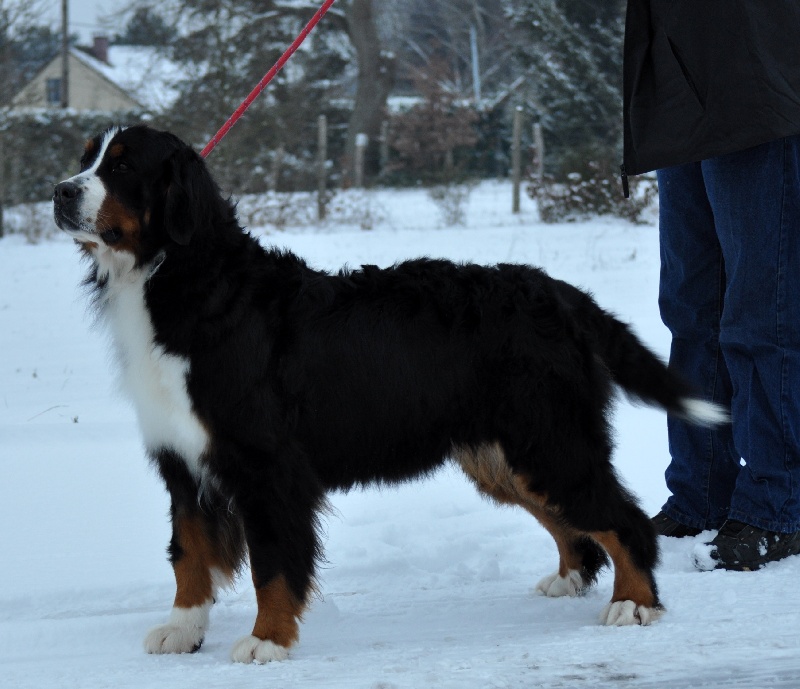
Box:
left=53, top=126, right=230, bottom=265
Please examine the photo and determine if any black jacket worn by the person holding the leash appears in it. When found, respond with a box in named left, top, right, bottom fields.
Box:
left=623, top=0, right=800, bottom=177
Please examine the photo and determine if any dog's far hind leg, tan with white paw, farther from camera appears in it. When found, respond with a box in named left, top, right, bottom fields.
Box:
left=453, top=443, right=608, bottom=597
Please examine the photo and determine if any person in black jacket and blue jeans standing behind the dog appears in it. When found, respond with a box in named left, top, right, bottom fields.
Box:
left=622, top=0, right=800, bottom=570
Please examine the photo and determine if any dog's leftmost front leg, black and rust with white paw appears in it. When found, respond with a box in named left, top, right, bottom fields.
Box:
left=144, top=448, right=244, bottom=653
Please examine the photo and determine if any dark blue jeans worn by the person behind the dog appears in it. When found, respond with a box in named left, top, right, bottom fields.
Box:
left=658, top=136, right=800, bottom=532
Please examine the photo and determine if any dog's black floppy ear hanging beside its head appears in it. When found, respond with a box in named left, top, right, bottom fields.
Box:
left=163, top=146, right=220, bottom=246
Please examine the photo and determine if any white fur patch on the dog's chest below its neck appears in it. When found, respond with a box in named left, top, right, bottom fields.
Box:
left=105, top=270, right=209, bottom=476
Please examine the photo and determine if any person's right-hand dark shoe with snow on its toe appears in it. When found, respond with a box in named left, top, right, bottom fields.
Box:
left=694, top=519, right=800, bottom=572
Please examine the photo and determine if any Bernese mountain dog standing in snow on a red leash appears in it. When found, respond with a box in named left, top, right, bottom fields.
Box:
left=53, top=126, right=725, bottom=663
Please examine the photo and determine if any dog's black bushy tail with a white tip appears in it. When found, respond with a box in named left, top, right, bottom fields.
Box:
left=559, top=281, right=730, bottom=426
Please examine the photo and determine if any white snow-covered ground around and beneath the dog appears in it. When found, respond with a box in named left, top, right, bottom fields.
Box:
left=0, top=183, right=800, bottom=689
